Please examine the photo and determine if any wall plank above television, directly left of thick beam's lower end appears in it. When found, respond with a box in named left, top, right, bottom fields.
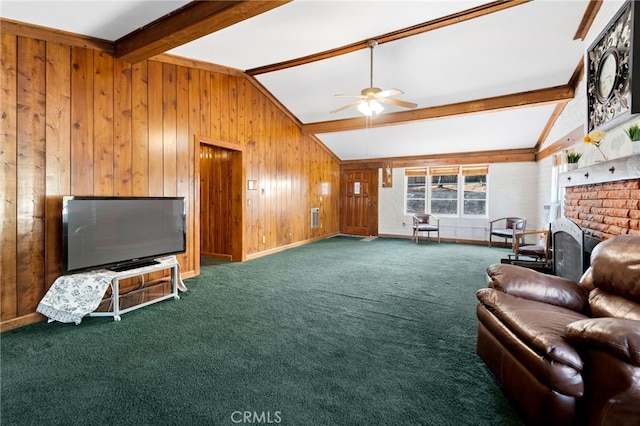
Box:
left=92, top=52, right=114, bottom=196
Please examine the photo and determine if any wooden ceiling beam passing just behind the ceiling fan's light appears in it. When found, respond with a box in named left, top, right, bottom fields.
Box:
left=302, top=85, right=575, bottom=134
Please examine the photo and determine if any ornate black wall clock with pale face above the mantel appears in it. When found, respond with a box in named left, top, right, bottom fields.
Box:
left=585, top=1, right=640, bottom=132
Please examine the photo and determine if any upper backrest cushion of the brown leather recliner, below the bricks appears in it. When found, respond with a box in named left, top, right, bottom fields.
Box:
left=591, top=235, right=640, bottom=303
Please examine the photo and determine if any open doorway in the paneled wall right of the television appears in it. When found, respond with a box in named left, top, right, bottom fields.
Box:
left=196, top=138, right=246, bottom=269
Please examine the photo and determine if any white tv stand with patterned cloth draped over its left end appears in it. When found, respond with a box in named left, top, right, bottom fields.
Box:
left=36, top=256, right=180, bottom=324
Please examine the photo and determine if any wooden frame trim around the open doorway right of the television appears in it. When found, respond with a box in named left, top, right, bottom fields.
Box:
left=193, top=136, right=247, bottom=274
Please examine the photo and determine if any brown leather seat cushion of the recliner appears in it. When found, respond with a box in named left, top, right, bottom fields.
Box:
left=477, top=288, right=587, bottom=370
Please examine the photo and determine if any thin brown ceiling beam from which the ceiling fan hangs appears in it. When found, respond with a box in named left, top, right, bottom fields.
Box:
left=245, top=0, right=531, bottom=75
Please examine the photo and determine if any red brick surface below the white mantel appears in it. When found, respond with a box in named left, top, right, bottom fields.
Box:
left=564, top=179, right=640, bottom=240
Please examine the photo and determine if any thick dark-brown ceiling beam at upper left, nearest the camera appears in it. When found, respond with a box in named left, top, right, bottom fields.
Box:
left=114, top=0, right=292, bottom=63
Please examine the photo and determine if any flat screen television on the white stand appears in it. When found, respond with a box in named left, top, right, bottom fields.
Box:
left=62, top=196, right=186, bottom=274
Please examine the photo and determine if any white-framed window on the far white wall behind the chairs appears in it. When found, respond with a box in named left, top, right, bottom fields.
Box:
left=405, top=166, right=489, bottom=217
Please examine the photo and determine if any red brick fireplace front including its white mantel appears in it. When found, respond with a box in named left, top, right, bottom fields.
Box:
left=560, top=155, right=640, bottom=240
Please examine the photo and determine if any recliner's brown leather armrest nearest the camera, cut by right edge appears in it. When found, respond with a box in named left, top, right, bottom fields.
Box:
left=565, top=317, right=640, bottom=367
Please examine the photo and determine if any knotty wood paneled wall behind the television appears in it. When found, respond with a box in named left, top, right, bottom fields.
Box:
left=0, top=33, right=339, bottom=329
